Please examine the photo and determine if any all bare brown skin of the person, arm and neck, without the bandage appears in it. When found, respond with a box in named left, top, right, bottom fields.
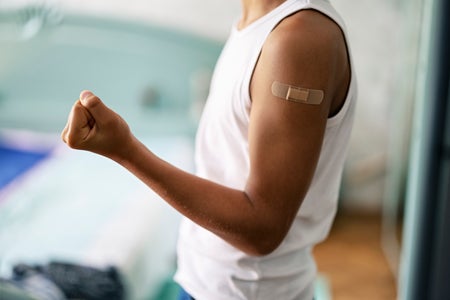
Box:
left=61, top=1, right=350, bottom=256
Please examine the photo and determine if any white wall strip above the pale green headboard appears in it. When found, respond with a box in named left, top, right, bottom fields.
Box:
left=0, top=0, right=240, bottom=41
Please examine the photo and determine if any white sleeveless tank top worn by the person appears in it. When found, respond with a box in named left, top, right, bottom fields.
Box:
left=175, top=0, right=356, bottom=300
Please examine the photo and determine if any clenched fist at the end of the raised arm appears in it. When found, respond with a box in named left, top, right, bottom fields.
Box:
left=61, top=91, right=134, bottom=160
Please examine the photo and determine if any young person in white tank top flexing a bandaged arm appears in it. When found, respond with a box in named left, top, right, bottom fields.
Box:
left=62, top=0, right=356, bottom=300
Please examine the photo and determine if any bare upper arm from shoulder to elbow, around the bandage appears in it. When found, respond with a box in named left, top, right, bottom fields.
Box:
left=246, top=11, right=346, bottom=251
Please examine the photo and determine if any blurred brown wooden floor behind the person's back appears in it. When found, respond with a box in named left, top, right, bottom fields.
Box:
left=314, top=214, right=396, bottom=300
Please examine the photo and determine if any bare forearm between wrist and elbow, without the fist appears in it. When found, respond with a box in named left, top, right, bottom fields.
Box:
left=113, top=138, right=276, bottom=255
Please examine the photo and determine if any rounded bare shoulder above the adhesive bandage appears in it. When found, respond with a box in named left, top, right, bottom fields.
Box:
left=259, top=10, right=350, bottom=115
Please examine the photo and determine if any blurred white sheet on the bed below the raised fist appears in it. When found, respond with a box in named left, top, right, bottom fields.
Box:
left=0, top=132, right=193, bottom=299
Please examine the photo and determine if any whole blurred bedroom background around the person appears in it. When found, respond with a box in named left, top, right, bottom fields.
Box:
left=0, top=0, right=450, bottom=300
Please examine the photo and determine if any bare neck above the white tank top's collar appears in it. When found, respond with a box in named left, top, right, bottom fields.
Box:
left=239, top=0, right=286, bottom=29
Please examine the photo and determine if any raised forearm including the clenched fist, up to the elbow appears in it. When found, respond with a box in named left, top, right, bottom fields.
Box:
left=61, top=91, right=282, bottom=254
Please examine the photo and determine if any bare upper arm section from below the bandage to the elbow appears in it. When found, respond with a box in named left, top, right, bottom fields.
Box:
left=246, top=78, right=326, bottom=230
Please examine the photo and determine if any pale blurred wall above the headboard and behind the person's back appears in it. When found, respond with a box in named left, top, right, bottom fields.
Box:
left=0, top=0, right=415, bottom=211
